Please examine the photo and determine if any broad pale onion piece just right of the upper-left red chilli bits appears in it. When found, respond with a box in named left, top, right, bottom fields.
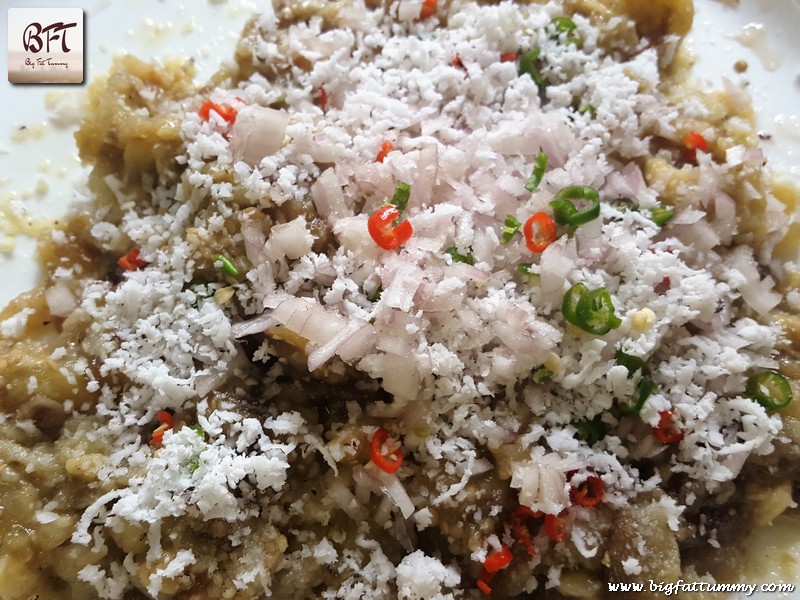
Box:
left=231, top=105, right=289, bottom=167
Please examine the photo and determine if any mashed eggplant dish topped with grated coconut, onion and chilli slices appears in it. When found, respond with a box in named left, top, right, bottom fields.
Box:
left=0, top=0, right=800, bottom=600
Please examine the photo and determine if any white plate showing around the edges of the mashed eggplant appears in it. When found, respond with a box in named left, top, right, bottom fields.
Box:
left=0, top=0, right=800, bottom=598
